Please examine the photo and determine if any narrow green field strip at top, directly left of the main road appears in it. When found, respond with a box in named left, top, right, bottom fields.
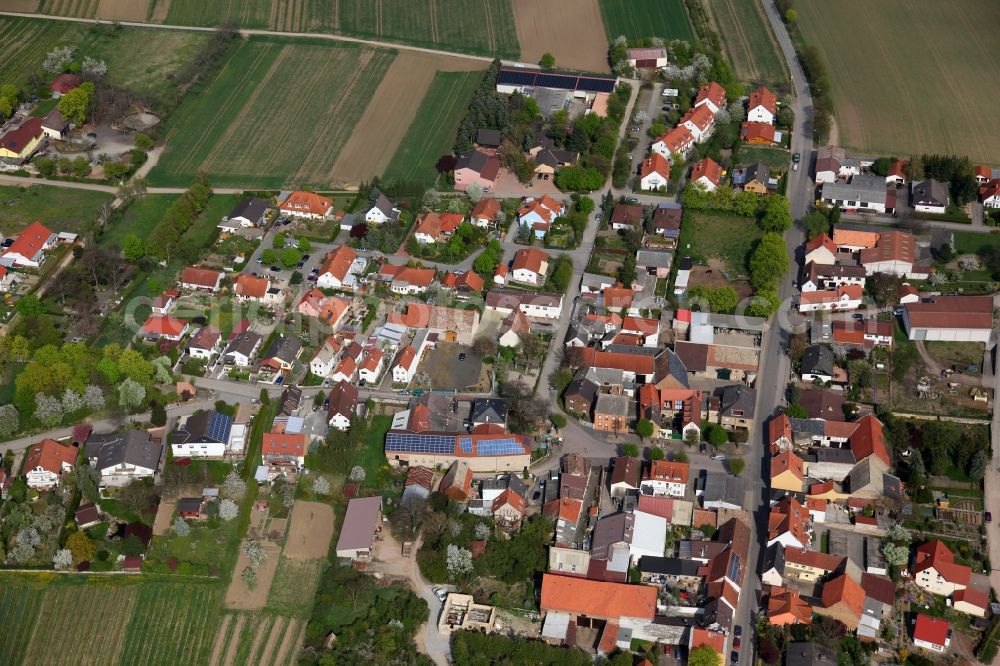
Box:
left=707, top=0, right=788, bottom=87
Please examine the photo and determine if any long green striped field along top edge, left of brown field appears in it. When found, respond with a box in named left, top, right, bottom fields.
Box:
left=161, top=0, right=520, bottom=58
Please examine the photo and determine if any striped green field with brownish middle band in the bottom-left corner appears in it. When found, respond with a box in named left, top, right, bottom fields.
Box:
left=0, top=574, right=222, bottom=666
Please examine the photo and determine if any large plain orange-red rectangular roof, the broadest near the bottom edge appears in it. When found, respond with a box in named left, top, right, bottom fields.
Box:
left=541, top=574, right=657, bottom=620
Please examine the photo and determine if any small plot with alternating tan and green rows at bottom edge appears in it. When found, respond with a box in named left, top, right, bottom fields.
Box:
left=208, top=613, right=306, bottom=666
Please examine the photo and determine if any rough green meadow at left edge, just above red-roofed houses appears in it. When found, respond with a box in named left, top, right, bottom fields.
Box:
left=0, top=185, right=113, bottom=235
